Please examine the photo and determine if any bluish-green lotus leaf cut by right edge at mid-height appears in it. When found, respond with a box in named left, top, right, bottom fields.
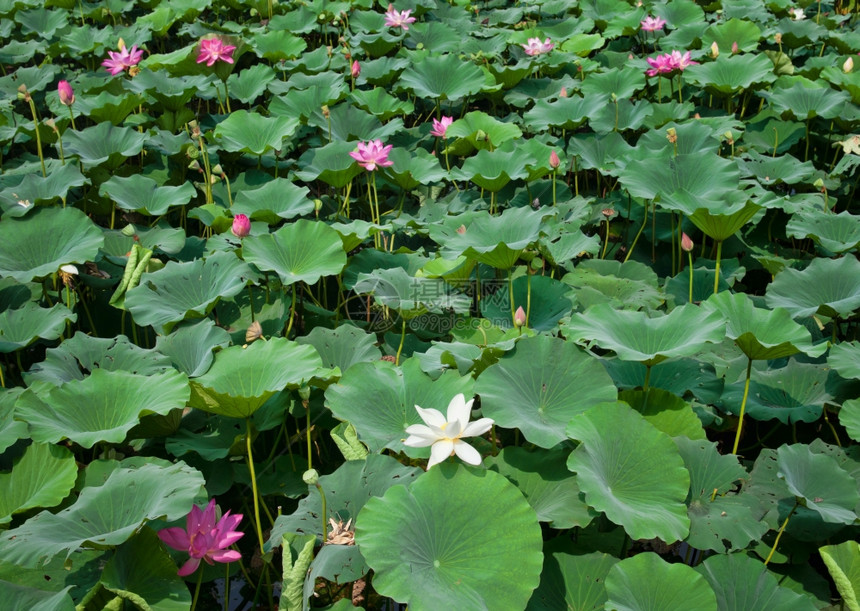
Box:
left=766, top=256, right=860, bottom=318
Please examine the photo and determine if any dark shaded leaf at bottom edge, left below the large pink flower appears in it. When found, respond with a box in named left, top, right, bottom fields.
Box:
left=101, top=526, right=191, bottom=611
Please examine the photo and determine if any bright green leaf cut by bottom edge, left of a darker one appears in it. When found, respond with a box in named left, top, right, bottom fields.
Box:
left=606, top=552, right=717, bottom=611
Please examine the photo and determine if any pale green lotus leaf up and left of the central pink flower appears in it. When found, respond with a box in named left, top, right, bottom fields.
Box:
left=215, top=110, right=299, bottom=155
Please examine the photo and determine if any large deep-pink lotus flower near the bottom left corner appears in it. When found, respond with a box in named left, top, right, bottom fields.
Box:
left=158, top=499, right=245, bottom=577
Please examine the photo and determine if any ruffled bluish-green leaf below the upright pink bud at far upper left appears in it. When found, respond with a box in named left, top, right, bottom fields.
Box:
left=63, top=121, right=146, bottom=169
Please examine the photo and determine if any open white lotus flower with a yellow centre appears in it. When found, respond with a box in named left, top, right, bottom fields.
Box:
left=403, top=393, right=493, bottom=470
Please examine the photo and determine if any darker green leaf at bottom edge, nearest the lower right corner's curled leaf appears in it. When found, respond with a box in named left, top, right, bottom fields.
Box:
left=696, top=554, right=817, bottom=611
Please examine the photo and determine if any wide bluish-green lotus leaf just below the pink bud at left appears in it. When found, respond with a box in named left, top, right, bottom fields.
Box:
left=125, top=251, right=255, bottom=332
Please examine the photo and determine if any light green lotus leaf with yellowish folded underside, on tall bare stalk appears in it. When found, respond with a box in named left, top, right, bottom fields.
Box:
left=189, top=337, right=332, bottom=418
